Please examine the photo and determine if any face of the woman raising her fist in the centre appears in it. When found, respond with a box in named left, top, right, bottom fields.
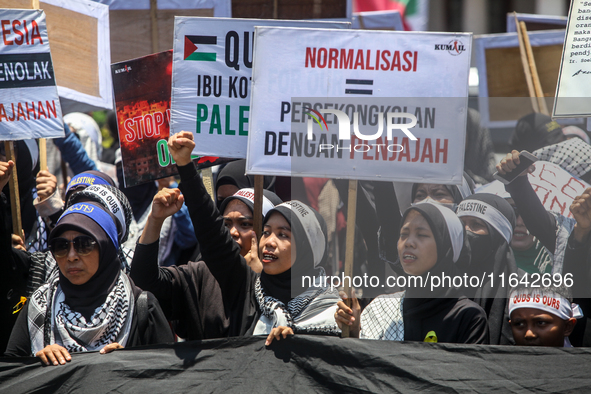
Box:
left=259, top=212, right=296, bottom=275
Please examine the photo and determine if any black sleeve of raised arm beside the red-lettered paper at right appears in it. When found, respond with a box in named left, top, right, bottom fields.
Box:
left=505, top=176, right=556, bottom=253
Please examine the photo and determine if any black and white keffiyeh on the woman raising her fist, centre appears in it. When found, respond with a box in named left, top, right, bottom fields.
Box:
left=254, top=268, right=341, bottom=335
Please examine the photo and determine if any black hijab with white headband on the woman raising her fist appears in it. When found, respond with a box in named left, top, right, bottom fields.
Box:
left=261, top=200, right=328, bottom=305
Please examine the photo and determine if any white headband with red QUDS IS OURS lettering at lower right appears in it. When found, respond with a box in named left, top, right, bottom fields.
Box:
left=509, top=291, right=583, bottom=320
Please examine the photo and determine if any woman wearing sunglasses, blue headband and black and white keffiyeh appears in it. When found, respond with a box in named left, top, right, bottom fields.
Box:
left=6, top=202, right=173, bottom=365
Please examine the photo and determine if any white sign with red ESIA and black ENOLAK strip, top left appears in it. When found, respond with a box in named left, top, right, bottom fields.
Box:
left=0, top=9, right=64, bottom=140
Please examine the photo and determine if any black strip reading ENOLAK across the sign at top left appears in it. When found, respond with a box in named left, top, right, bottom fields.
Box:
left=0, top=52, right=55, bottom=89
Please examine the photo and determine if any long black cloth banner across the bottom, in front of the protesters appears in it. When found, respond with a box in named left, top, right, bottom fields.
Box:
left=0, top=335, right=591, bottom=394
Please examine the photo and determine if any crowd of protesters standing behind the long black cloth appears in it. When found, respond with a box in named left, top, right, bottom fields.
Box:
left=0, top=109, right=591, bottom=365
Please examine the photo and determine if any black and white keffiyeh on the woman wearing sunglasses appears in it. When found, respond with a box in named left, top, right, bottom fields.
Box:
left=27, top=273, right=134, bottom=355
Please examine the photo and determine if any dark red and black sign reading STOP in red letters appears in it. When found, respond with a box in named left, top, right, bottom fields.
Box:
left=111, top=51, right=227, bottom=187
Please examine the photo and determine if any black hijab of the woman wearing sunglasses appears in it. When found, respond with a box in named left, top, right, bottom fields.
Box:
left=48, top=202, right=121, bottom=319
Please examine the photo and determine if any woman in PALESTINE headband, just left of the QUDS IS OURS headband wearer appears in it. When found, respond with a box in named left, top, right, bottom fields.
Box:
left=457, top=193, right=521, bottom=345
